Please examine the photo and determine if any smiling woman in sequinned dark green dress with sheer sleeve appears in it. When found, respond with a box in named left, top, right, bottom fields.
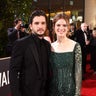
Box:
left=49, top=14, right=82, bottom=96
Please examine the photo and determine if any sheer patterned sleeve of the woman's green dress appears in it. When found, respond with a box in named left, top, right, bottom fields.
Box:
left=75, top=43, right=82, bottom=96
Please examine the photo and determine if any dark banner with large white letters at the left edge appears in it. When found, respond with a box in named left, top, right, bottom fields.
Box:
left=0, top=57, right=11, bottom=96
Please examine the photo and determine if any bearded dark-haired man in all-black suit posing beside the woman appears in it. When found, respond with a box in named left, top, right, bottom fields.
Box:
left=9, top=10, right=51, bottom=96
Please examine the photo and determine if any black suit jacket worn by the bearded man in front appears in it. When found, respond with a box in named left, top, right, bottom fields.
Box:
left=9, top=35, right=50, bottom=96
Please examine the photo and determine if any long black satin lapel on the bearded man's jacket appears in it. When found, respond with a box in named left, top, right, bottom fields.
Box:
left=30, top=39, right=41, bottom=76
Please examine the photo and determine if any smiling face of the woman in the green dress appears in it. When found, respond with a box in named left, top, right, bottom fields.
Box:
left=54, top=19, right=68, bottom=36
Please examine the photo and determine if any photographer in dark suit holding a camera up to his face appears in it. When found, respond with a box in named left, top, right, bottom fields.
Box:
left=7, top=18, right=28, bottom=56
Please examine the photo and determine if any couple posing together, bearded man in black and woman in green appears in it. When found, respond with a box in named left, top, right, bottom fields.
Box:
left=9, top=10, right=82, bottom=96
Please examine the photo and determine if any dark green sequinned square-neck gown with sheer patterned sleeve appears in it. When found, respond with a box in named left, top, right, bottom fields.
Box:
left=49, top=43, right=82, bottom=96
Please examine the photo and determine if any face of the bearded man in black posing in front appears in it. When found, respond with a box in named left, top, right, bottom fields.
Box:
left=30, top=16, right=47, bottom=36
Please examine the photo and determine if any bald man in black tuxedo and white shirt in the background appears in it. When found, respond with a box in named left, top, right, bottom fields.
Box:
left=75, top=23, right=90, bottom=79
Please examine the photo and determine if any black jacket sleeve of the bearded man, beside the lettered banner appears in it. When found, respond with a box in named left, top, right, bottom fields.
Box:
left=9, top=41, right=23, bottom=96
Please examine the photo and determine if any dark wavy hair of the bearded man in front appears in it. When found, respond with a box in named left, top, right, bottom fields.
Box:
left=29, top=10, right=47, bottom=24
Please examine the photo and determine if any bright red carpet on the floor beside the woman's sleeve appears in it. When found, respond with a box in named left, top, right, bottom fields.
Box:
left=81, top=54, right=96, bottom=96
